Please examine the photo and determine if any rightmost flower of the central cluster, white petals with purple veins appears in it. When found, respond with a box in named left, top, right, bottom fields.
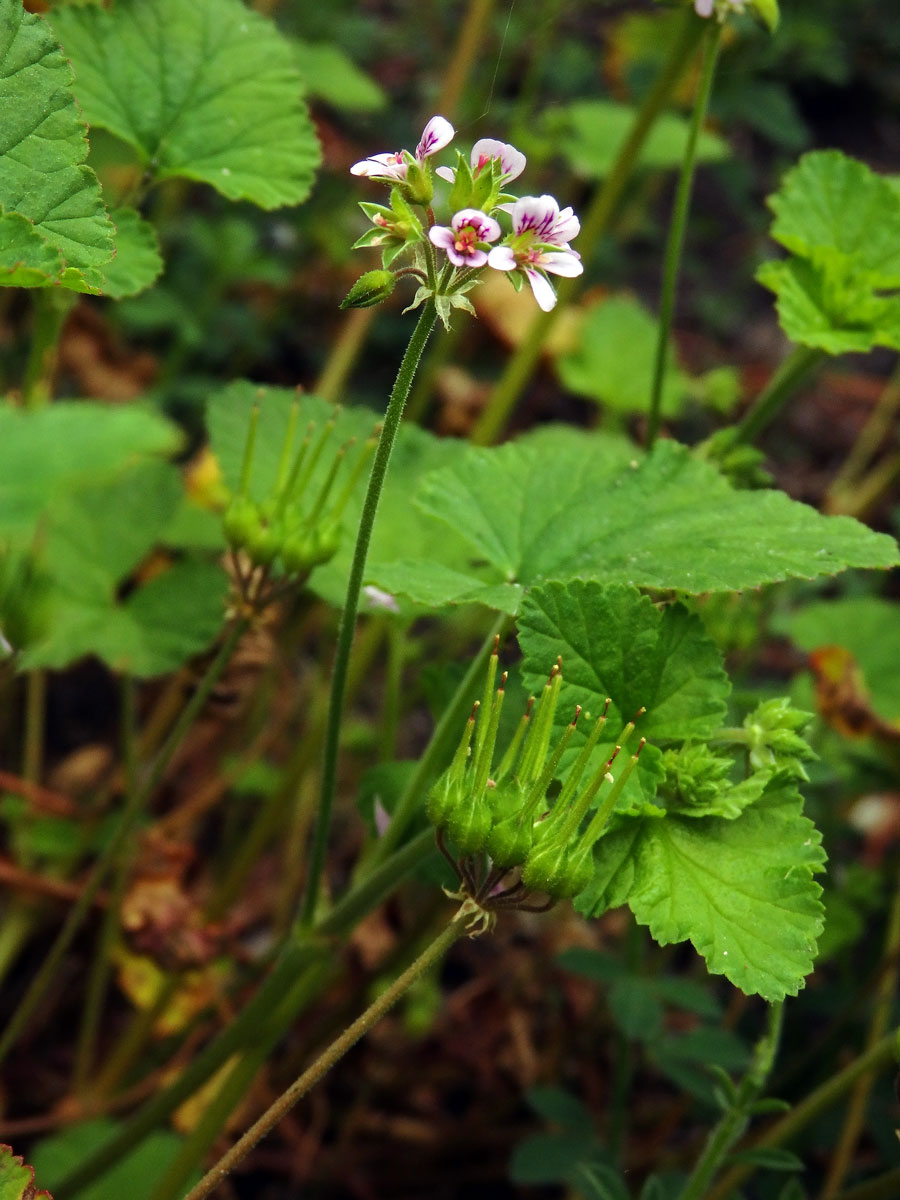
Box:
left=487, top=196, right=584, bottom=312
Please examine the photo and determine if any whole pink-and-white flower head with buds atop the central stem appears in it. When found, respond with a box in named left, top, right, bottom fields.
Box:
left=344, top=116, right=583, bottom=323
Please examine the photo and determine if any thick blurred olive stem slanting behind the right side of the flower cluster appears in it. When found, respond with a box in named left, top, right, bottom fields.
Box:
left=470, top=11, right=706, bottom=445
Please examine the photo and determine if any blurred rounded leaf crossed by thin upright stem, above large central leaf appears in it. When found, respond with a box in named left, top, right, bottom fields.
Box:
left=556, top=296, right=690, bottom=416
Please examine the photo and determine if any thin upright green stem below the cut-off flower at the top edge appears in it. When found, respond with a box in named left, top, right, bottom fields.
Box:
left=647, top=20, right=722, bottom=449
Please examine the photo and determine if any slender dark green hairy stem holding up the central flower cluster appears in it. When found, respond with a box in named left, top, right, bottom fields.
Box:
left=301, top=300, right=436, bottom=925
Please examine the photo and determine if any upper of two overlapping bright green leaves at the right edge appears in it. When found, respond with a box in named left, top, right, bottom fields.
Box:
left=768, top=150, right=900, bottom=288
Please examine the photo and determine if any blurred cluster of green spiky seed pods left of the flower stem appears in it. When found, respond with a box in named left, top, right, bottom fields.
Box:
left=222, top=401, right=376, bottom=582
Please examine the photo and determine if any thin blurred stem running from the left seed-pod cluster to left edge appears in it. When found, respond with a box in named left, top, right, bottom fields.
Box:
left=0, top=620, right=246, bottom=1062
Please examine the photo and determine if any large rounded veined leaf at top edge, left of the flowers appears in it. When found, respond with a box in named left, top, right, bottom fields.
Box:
left=53, top=0, right=319, bottom=209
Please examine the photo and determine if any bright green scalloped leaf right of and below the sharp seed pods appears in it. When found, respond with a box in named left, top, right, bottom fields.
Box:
left=576, top=776, right=824, bottom=1001
